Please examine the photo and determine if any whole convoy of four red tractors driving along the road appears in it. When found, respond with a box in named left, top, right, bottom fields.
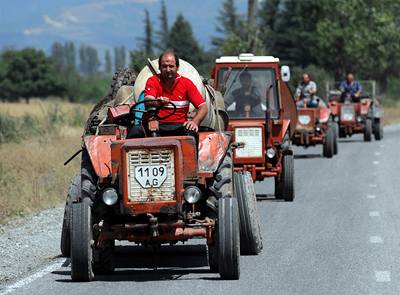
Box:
left=61, top=54, right=383, bottom=281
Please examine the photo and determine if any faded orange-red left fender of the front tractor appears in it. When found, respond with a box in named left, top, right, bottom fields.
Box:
left=83, top=135, right=116, bottom=179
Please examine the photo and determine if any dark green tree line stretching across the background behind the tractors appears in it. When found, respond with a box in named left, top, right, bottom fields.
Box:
left=0, top=0, right=400, bottom=101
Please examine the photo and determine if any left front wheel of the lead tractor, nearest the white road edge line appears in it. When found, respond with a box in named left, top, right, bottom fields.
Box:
left=71, top=198, right=94, bottom=282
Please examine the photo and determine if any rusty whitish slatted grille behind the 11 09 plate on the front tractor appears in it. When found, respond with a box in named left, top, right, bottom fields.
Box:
left=126, top=149, right=175, bottom=202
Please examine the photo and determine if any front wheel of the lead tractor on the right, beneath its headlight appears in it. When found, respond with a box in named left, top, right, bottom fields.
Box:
left=216, top=197, right=240, bottom=280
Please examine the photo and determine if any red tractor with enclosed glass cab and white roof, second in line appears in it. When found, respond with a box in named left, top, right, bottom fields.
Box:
left=211, top=53, right=297, bottom=201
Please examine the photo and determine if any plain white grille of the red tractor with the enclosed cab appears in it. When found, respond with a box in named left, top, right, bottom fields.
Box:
left=235, top=128, right=263, bottom=158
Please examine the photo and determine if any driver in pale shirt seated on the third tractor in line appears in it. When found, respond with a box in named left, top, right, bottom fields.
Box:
left=295, top=73, right=318, bottom=108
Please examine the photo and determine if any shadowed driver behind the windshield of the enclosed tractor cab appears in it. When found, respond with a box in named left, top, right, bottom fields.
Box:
left=225, top=70, right=265, bottom=117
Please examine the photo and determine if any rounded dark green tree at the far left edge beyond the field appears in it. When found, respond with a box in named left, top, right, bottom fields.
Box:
left=0, top=48, right=64, bottom=103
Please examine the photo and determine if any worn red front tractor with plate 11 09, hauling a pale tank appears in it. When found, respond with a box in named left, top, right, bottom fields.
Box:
left=61, top=60, right=262, bottom=281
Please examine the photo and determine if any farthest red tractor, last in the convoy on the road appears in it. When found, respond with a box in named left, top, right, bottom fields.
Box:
left=327, top=81, right=383, bottom=141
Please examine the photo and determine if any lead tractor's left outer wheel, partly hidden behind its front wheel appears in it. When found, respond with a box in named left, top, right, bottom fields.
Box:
left=60, top=175, right=81, bottom=257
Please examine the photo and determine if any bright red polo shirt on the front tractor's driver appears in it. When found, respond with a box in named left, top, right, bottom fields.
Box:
left=144, top=74, right=205, bottom=123
